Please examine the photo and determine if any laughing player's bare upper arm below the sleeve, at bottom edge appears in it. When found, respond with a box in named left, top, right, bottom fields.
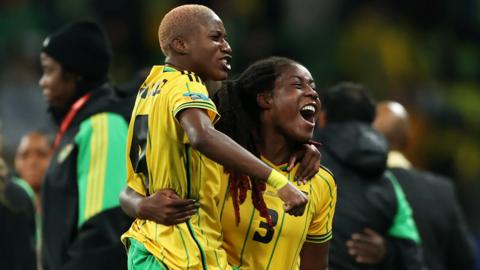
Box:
left=300, top=241, right=330, bottom=270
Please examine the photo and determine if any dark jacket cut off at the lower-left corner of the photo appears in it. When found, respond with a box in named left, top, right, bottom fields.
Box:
left=0, top=180, right=37, bottom=270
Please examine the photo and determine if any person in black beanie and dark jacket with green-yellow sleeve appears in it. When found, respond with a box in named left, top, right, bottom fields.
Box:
left=39, top=20, right=131, bottom=270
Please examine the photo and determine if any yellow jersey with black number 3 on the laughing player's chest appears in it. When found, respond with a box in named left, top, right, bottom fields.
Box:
left=219, top=158, right=337, bottom=270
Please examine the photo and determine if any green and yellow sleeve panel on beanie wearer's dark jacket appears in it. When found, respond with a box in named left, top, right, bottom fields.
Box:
left=75, top=113, right=128, bottom=227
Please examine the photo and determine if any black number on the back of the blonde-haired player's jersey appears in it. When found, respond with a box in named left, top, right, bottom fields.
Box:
left=129, top=115, right=150, bottom=196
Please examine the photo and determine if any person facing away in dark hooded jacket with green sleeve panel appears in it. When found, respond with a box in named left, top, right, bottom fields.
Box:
left=315, top=82, right=424, bottom=270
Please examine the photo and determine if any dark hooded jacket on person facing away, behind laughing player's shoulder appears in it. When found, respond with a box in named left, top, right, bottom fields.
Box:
left=315, top=122, right=422, bottom=270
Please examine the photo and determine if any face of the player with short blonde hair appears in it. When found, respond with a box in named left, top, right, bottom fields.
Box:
left=186, top=12, right=232, bottom=81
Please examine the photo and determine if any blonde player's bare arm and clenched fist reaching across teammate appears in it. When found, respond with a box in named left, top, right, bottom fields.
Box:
left=177, top=108, right=308, bottom=216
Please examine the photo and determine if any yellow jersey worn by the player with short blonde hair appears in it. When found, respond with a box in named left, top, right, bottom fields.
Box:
left=122, top=66, right=229, bottom=269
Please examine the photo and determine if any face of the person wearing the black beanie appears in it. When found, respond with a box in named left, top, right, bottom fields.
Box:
left=38, top=52, right=76, bottom=107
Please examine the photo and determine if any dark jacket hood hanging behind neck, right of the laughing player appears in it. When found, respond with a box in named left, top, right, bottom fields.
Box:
left=318, top=122, right=388, bottom=176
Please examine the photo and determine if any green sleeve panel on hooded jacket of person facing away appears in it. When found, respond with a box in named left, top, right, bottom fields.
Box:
left=385, top=171, right=421, bottom=244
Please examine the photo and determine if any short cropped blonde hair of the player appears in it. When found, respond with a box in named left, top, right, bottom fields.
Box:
left=158, top=4, right=215, bottom=55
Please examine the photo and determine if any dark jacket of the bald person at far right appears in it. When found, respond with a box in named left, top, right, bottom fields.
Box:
left=390, top=168, right=475, bottom=270
